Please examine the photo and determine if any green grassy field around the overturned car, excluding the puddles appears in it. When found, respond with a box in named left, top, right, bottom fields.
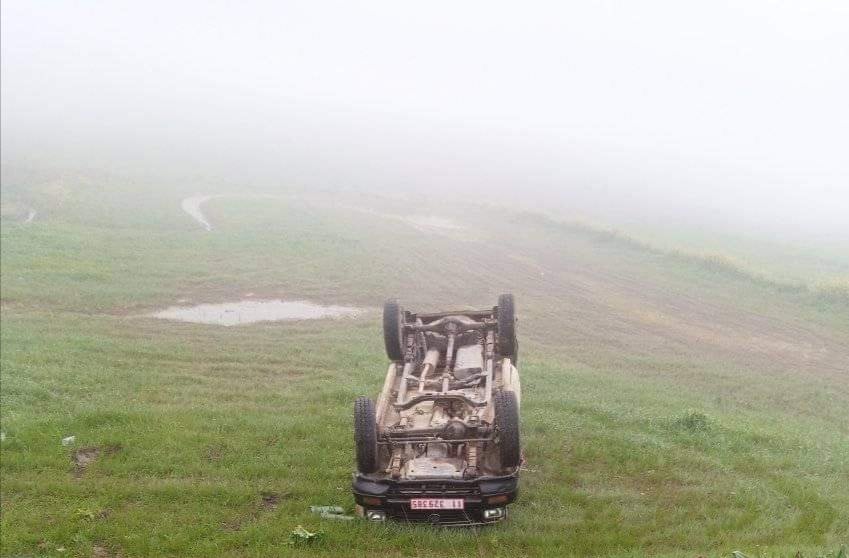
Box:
left=0, top=179, right=849, bottom=557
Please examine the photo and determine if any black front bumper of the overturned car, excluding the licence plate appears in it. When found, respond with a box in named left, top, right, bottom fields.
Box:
left=352, top=474, right=519, bottom=526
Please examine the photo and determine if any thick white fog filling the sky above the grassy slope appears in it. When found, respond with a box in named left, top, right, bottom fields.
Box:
left=2, top=0, right=849, bottom=239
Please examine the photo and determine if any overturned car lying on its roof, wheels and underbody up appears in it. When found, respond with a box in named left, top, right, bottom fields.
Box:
left=353, top=294, right=522, bottom=525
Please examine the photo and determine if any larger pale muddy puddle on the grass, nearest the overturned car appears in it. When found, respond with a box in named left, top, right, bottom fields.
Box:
left=151, top=300, right=362, bottom=326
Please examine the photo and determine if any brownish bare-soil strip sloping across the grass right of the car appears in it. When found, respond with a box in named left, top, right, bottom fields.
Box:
left=408, top=211, right=849, bottom=393
